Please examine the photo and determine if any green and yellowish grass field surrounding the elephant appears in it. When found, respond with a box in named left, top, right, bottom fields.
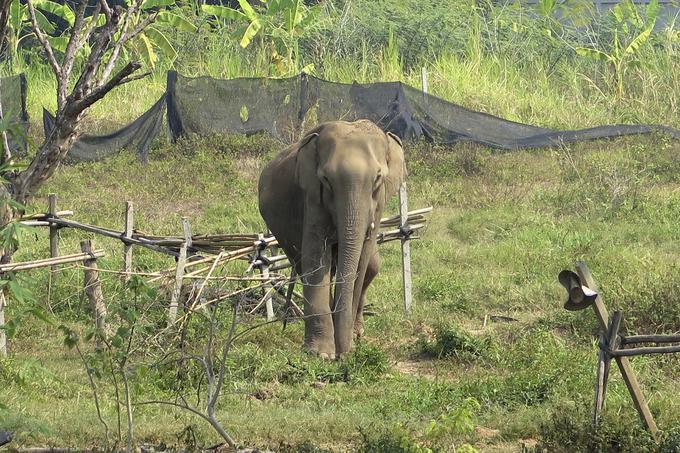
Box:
left=0, top=2, right=680, bottom=452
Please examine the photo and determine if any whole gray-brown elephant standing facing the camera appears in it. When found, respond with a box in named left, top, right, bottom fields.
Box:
left=258, top=120, right=404, bottom=358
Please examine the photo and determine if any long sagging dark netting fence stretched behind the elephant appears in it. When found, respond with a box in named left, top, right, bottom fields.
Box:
left=35, top=72, right=680, bottom=160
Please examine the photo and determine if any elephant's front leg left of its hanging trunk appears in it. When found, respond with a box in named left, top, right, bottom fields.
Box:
left=301, top=219, right=335, bottom=359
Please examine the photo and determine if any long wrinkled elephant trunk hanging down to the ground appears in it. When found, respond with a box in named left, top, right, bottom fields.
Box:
left=333, top=196, right=372, bottom=354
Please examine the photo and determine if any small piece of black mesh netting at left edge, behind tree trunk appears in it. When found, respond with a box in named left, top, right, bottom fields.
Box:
left=0, top=74, right=28, bottom=152
